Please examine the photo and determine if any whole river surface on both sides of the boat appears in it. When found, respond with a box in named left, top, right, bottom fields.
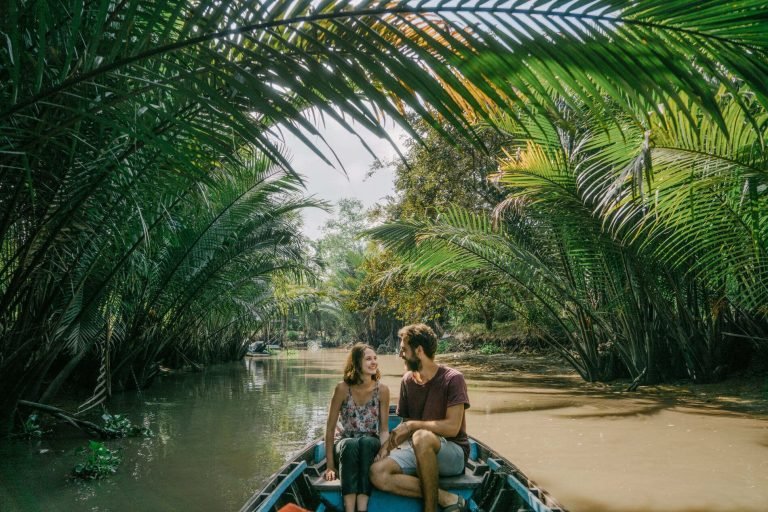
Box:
left=0, top=350, right=768, bottom=512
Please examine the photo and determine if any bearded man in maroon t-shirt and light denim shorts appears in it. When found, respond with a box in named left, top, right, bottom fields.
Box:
left=371, top=324, right=469, bottom=512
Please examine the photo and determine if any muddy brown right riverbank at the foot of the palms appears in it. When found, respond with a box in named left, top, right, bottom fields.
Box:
left=437, top=351, right=768, bottom=417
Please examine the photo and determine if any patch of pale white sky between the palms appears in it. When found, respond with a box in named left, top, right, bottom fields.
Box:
left=284, top=117, right=405, bottom=239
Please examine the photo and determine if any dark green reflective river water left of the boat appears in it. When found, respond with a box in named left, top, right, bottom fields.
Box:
left=0, top=357, right=338, bottom=512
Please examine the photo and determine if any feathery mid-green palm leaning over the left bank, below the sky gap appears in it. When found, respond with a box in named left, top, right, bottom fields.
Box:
left=104, top=159, right=314, bottom=388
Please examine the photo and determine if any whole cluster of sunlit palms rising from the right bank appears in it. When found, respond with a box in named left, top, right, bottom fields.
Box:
left=373, top=95, right=768, bottom=382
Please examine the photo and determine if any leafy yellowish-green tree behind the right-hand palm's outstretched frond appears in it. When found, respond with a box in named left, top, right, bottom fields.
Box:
left=346, top=121, right=510, bottom=332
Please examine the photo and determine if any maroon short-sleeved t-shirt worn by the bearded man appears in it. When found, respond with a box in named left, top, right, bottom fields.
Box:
left=397, top=365, right=469, bottom=461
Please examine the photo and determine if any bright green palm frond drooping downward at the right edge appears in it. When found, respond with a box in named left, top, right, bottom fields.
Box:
left=585, top=95, right=768, bottom=314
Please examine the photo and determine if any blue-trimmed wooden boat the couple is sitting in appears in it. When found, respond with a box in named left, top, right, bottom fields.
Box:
left=240, top=407, right=566, bottom=512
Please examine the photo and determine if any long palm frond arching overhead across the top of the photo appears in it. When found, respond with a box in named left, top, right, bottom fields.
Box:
left=0, top=1, right=768, bottom=166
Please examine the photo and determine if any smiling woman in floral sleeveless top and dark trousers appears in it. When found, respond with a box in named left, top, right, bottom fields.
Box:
left=325, top=343, right=389, bottom=512
